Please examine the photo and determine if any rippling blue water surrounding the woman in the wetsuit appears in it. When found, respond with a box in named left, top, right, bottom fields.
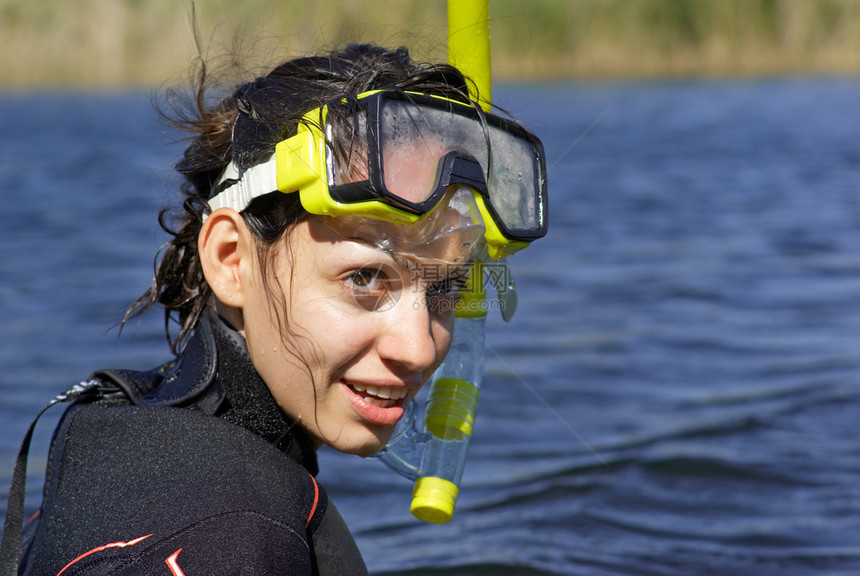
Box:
left=0, top=78, right=860, bottom=576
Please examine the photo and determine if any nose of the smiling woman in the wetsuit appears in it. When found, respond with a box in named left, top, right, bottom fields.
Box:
left=377, top=298, right=437, bottom=372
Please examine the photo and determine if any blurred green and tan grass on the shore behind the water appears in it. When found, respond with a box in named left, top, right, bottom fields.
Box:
left=0, top=0, right=860, bottom=88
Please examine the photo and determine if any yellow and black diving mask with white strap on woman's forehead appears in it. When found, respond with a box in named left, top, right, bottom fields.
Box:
left=209, top=90, right=547, bottom=257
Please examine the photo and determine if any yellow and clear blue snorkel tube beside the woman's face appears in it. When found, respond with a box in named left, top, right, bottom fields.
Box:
left=377, top=0, right=516, bottom=524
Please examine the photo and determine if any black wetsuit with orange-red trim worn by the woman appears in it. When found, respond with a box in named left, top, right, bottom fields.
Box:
left=20, top=312, right=367, bottom=576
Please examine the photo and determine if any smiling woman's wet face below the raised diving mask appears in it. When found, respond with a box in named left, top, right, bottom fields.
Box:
left=243, top=217, right=464, bottom=456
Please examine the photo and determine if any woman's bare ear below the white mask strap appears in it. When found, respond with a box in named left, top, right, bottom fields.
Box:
left=197, top=208, right=256, bottom=308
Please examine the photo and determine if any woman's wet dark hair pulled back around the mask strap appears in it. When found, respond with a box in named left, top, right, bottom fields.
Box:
left=127, top=44, right=469, bottom=355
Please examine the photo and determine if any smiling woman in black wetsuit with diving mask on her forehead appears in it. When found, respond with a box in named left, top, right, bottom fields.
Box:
left=1, top=45, right=545, bottom=575
